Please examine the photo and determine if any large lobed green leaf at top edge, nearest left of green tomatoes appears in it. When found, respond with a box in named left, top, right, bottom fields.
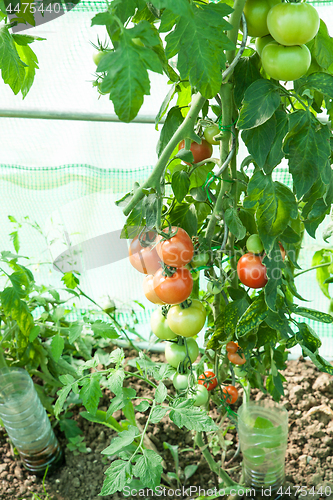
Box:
left=160, top=0, right=234, bottom=99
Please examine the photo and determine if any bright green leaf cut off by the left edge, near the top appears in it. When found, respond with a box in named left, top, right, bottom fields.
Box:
left=0, top=26, right=26, bottom=94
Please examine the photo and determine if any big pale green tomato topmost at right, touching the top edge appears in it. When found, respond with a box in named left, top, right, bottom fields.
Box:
left=267, top=2, right=320, bottom=45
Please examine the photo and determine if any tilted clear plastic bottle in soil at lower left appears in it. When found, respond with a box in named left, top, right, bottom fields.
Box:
left=0, top=368, right=63, bottom=476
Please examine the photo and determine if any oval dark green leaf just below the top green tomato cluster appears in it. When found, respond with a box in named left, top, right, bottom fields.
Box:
left=236, top=79, right=281, bottom=129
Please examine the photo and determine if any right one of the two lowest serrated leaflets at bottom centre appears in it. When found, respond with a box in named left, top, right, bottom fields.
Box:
left=133, top=449, right=163, bottom=488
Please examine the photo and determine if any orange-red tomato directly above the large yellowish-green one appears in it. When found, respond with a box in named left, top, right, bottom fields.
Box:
left=153, top=267, right=193, bottom=304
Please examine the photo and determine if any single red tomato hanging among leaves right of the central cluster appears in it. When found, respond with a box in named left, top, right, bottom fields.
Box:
left=237, top=253, right=267, bottom=288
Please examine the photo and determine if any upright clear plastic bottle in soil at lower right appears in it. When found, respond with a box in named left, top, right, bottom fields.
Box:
left=238, top=401, right=288, bottom=493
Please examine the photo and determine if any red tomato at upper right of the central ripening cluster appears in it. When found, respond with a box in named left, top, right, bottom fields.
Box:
left=156, top=226, right=194, bottom=267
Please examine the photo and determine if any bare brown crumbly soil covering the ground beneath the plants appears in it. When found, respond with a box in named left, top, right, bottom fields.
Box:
left=0, top=353, right=333, bottom=500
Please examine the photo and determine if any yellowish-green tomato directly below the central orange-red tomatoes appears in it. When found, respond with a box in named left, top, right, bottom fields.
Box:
left=167, top=299, right=206, bottom=337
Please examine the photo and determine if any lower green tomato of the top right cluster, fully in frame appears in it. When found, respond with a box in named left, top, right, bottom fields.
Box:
left=261, top=43, right=311, bottom=81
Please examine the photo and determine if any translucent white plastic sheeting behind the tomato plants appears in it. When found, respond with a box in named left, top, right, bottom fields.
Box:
left=0, top=2, right=333, bottom=357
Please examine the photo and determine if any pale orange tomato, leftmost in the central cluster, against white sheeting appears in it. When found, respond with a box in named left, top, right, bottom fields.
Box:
left=128, top=232, right=161, bottom=274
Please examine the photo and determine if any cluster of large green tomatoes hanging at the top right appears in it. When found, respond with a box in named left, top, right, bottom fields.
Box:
left=244, top=0, right=320, bottom=81
